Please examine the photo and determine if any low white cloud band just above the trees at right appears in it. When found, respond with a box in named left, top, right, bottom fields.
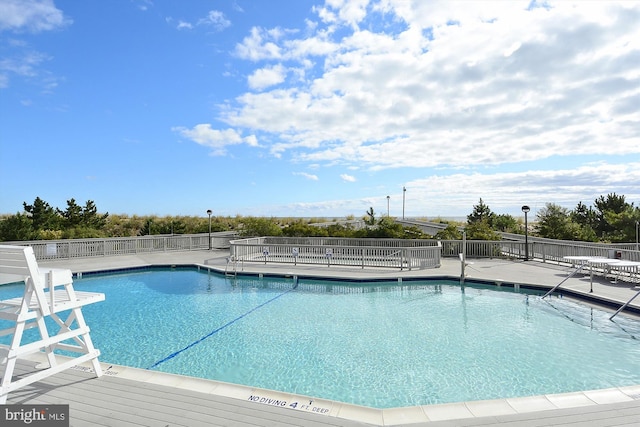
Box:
left=272, top=162, right=640, bottom=219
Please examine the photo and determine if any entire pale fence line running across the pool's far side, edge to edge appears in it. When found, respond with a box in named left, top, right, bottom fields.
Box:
left=2, top=231, right=640, bottom=268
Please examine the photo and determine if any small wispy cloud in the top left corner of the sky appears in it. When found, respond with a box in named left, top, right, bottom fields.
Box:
left=0, top=0, right=72, bottom=33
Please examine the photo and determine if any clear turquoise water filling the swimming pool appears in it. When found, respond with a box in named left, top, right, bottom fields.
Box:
left=0, top=269, right=640, bottom=408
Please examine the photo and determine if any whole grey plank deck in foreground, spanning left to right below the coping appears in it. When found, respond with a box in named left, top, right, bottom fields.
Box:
left=7, top=360, right=640, bottom=427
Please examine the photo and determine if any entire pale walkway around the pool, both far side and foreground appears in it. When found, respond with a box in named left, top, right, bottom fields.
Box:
left=7, top=251, right=640, bottom=426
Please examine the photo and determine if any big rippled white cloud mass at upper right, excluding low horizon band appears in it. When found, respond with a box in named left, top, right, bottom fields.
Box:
left=212, top=0, right=640, bottom=170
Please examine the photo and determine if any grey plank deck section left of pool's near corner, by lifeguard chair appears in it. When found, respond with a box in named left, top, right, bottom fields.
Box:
left=7, top=360, right=370, bottom=427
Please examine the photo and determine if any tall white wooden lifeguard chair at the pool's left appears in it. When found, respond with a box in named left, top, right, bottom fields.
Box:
left=0, top=245, right=105, bottom=404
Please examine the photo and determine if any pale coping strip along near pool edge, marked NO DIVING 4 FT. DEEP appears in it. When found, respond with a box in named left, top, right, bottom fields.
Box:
left=13, top=353, right=640, bottom=426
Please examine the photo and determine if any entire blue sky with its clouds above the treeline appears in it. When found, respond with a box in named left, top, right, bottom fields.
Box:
left=0, top=0, right=640, bottom=218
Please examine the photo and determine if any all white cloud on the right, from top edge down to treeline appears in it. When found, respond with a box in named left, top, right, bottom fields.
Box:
left=178, top=0, right=640, bottom=221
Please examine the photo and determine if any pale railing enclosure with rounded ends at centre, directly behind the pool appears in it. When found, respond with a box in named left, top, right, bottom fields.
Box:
left=230, top=237, right=441, bottom=270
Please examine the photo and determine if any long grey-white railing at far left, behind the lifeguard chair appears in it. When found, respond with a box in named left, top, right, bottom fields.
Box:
left=1, top=231, right=237, bottom=260
